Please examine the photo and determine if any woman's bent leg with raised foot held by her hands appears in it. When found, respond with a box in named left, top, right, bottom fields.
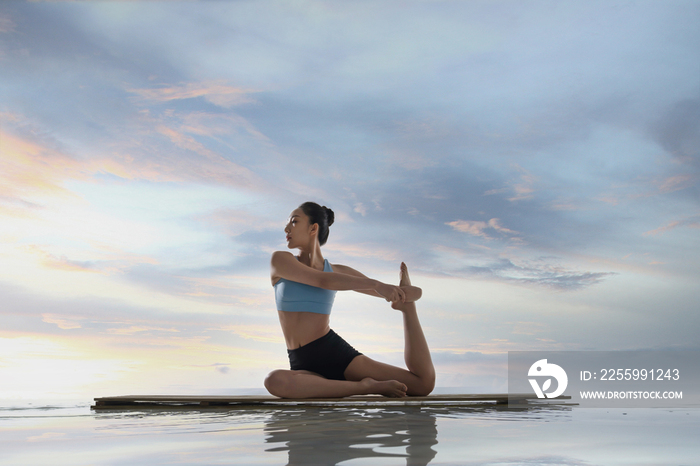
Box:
left=345, top=262, right=435, bottom=396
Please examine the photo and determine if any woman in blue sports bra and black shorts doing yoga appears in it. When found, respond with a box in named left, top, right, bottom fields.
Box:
left=265, top=202, right=435, bottom=398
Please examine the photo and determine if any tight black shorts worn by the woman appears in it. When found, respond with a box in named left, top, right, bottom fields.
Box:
left=287, top=330, right=362, bottom=380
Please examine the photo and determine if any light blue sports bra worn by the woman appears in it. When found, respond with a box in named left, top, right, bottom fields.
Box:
left=275, top=259, right=335, bottom=314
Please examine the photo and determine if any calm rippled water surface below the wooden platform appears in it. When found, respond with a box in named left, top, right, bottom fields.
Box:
left=0, top=405, right=700, bottom=466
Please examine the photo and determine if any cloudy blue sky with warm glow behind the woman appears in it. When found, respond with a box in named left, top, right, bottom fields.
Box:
left=0, top=0, right=700, bottom=400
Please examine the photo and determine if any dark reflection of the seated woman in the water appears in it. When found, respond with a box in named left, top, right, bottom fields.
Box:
left=264, top=407, right=438, bottom=465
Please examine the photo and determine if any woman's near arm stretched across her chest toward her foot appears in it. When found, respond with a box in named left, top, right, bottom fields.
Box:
left=270, top=251, right=405, bottom=302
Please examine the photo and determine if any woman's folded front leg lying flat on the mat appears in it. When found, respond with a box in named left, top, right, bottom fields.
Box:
left=265, top=370, right=406, bottom=398
